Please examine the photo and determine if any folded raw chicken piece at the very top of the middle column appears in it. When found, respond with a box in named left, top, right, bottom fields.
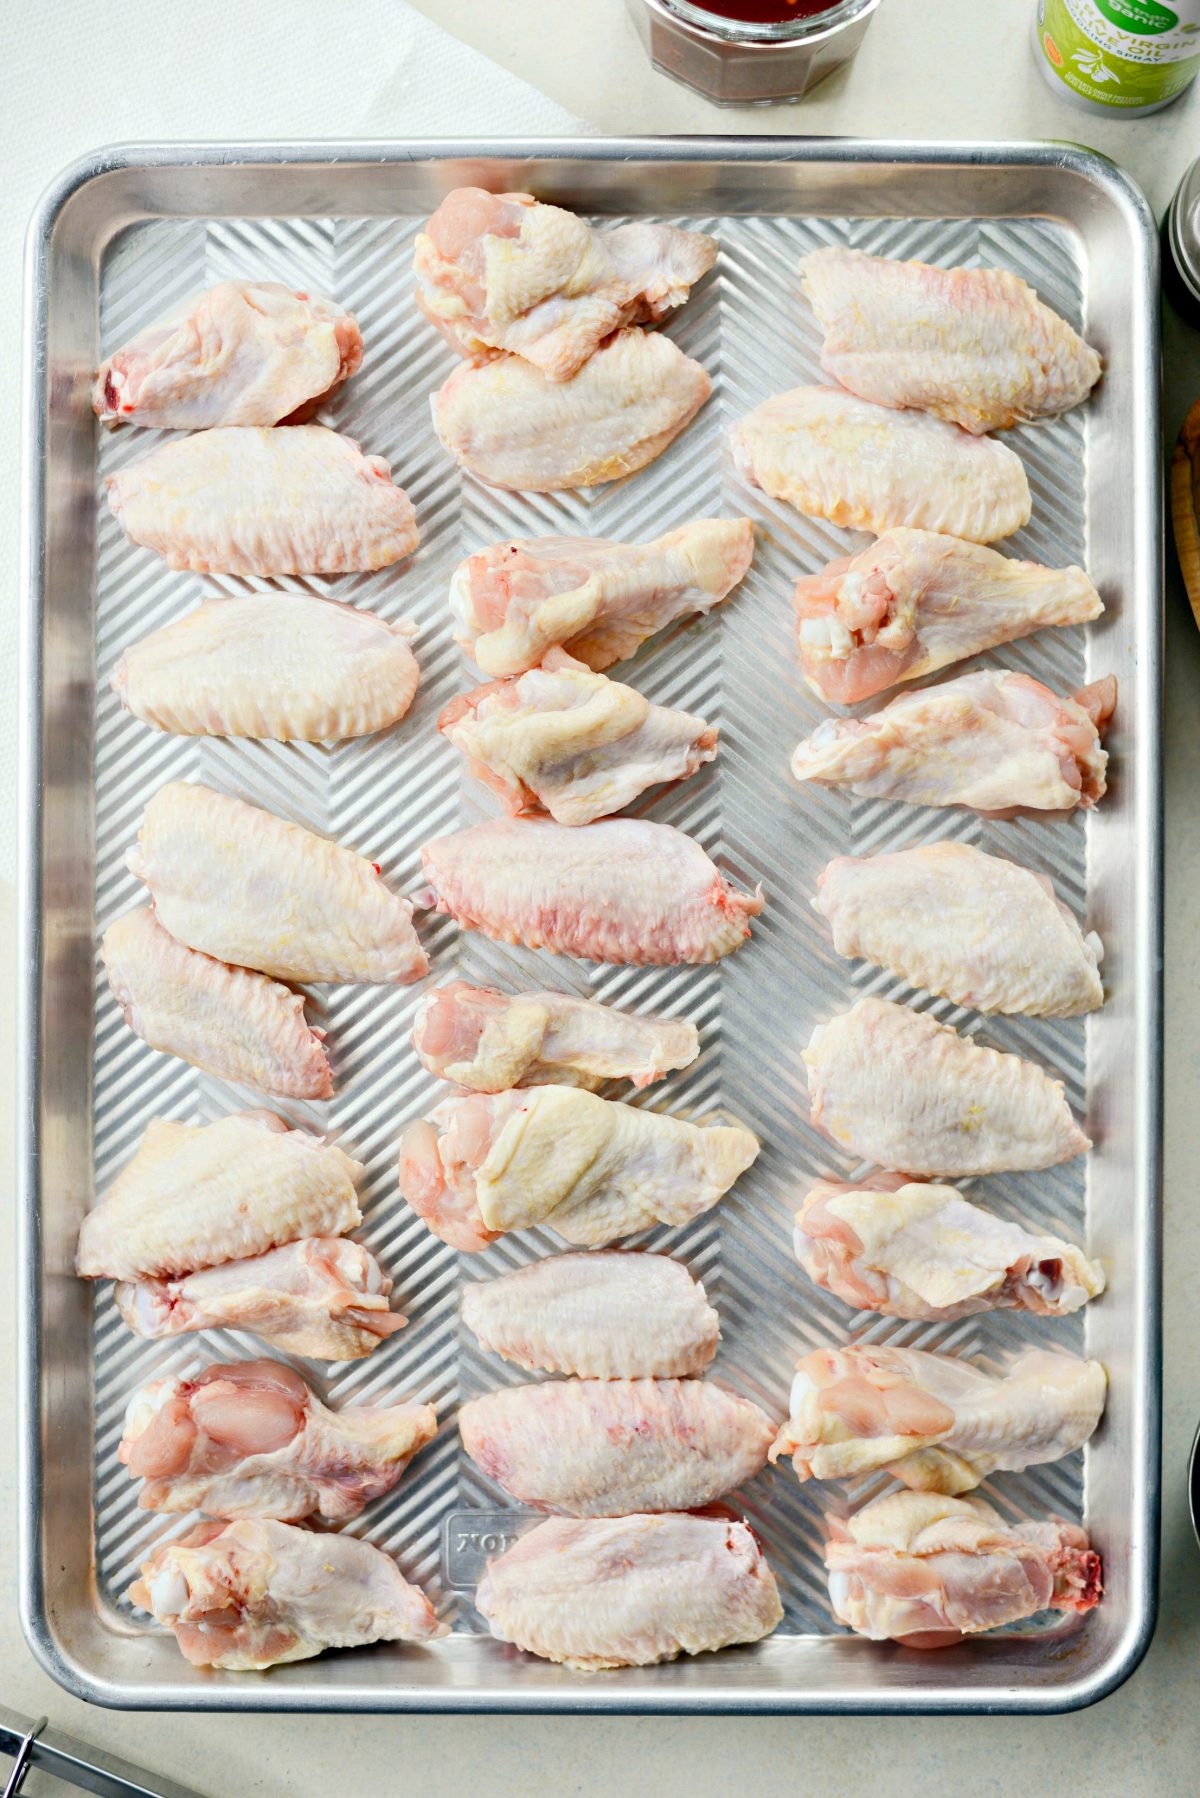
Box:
left=412, top=187, right=716, bottom=381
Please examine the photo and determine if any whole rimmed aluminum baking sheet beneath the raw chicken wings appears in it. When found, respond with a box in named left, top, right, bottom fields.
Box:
left=22, top=138, right=1160, bottom=1712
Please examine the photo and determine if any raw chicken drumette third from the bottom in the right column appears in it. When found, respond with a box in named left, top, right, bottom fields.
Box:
left=793, top=1174, right=1105, bottom=1322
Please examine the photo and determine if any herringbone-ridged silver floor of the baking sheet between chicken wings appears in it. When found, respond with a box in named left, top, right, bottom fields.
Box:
left=94, top=206, right=1087, bottom=1633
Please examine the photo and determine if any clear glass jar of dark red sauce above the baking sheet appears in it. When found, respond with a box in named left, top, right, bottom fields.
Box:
left=628, top=0, right=880, bottom=106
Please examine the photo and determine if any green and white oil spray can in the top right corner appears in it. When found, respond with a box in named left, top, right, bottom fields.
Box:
left=1034, top=0, right=1200, bottom=119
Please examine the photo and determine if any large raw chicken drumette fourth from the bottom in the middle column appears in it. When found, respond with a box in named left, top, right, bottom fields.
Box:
left=399, top=1086, right=759, bottom=1250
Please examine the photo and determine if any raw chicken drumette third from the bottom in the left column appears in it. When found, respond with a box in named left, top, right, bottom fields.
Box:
left=113, top=1237, right=407, bottom=1361
